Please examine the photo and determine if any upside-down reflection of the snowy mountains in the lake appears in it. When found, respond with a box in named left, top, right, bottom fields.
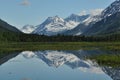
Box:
left=22, top=50, right=120, bottom=80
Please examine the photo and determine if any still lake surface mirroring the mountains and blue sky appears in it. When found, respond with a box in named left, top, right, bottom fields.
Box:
left=0, top=50, right=120, bottom=80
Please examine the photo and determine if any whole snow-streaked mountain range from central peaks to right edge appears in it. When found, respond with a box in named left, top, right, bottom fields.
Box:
left=25, top=0, right=120, bottom=36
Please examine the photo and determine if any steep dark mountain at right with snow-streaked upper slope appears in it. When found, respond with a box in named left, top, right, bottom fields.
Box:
left=66, top=0, right=120, bottom=36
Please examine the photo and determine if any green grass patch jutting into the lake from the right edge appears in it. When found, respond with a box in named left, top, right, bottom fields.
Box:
left=90, top=54, right=120, bottom=67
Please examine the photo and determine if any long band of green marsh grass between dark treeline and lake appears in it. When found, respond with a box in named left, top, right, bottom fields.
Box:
left=0, top=42, right=120, bottom=51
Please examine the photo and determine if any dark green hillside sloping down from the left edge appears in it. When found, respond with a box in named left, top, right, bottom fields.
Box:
left=0, top=19, right=22, bottom=42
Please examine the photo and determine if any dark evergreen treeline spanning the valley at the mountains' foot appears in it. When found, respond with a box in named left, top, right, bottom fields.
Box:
left=0, top=32, right=120, bottom=42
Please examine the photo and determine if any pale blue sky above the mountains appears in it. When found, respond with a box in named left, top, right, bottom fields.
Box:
left=0, top=0, right=115, bottom=29
